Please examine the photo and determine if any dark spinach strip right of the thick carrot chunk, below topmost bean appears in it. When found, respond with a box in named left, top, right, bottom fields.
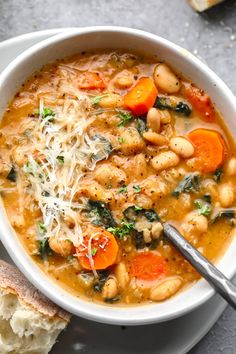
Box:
left=154, top=96, right=192, bottom=117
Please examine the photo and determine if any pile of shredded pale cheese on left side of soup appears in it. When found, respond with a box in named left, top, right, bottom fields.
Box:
left=21, top=95, right=111, bottom=246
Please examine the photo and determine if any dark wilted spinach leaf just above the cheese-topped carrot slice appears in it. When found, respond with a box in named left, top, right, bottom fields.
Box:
left=88, top=200, right=116, bottom=228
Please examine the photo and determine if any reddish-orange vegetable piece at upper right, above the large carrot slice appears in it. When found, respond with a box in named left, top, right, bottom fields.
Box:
left=184, top=84, right=215, bottom=123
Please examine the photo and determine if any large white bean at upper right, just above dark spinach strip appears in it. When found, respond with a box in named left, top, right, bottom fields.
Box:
left=154, top=64, right=181, bottom=93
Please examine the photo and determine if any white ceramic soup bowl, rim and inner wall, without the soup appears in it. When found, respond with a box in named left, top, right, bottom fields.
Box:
left=0, top=27, right=236, bottom=325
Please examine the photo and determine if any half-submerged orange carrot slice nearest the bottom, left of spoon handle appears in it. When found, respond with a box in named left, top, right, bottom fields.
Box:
left=130, top=252, right=167, bottom=280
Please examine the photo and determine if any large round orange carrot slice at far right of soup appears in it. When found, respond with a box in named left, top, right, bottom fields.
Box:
left=188, top=129, right=225, bottom=173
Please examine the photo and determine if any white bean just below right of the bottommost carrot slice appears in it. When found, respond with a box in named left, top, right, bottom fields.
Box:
left=150, top=277, right=182, bottom=301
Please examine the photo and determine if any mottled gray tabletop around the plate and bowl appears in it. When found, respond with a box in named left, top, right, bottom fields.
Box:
left=0, top=0, right=236, bottom=354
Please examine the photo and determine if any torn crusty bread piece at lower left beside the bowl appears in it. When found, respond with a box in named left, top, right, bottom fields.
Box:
left=0, top=261, right=70, bottom=354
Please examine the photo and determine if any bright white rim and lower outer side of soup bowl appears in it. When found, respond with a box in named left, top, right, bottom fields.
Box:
left=0, top=26, right=236, bottom=325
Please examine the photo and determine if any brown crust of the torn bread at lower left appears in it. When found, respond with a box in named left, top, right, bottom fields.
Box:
left=0, top=260, right=71, bottom=323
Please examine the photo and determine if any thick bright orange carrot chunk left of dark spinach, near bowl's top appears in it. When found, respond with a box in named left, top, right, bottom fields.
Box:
left=124, top=77, right=158, bottom=115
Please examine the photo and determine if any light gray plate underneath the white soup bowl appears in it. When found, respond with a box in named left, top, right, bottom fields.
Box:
left=0, top=29, right=226, bottom=354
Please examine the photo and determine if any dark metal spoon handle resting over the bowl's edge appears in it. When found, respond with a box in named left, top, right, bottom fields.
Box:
left=163, top=223, right=236, bottom=309
